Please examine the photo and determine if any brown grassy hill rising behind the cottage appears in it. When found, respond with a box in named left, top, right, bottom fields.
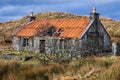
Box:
left=0, top=12, right=120, bottom=42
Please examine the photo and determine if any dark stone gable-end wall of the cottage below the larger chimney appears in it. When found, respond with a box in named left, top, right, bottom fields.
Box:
left=81, top=22, right=110, bottom=53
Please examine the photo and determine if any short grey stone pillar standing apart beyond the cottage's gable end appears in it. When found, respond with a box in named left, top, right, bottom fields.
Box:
left=112, top=42, right=120, bottom=56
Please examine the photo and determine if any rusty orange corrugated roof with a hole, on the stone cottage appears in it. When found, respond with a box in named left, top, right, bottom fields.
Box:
left=16, top=17, right=89, bottom=38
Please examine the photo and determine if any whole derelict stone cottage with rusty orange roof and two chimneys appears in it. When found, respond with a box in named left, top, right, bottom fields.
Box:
left=13, top=8, right=110, bottom=55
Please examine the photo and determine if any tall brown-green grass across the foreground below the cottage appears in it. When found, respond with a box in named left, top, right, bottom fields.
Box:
left=0, top=56, right=120, bottom=80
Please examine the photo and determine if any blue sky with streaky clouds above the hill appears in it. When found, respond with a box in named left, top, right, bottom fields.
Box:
left=0, top=0, right=120, bottom=22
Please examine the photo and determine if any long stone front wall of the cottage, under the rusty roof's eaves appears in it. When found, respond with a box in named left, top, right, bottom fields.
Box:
left=13, top=36, right=81, bottom=56
